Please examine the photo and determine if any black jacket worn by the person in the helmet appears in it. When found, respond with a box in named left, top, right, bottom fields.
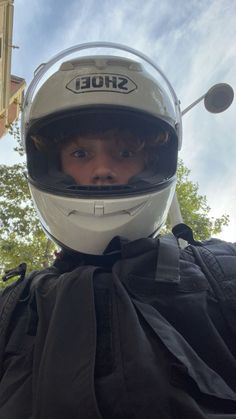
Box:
left=0, top=235, right=236, bottom=419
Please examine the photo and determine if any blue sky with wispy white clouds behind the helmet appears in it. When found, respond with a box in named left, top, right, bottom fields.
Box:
left=0, top=0, right=236, bottom=241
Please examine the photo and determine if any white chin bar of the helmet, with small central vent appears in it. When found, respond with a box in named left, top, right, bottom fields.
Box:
left=29, top=179, right=176, bottom=255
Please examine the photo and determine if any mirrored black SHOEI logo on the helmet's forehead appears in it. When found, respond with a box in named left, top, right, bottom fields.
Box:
left=66, top=74, right=137, bottom=93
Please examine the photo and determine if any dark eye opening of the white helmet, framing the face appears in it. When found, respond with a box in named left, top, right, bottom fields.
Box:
left=27, top=108, right=178, bottom=198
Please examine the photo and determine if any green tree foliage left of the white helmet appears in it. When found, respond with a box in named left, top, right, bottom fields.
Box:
left=0, top=164, right=55, bottom=284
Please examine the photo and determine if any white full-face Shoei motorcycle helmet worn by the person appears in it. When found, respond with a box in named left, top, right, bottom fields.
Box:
left=22, top=43, right=181, bottom=255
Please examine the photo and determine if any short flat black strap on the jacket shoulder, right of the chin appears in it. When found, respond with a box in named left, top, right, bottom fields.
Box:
left=156, top=234, right=180, bottom=283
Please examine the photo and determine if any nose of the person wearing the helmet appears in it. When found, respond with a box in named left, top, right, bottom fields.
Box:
left=92, top=156, right=117, bottom=185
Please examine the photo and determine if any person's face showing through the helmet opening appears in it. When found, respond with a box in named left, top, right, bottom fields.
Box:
left=61, top=130, right=145, bottom=186
